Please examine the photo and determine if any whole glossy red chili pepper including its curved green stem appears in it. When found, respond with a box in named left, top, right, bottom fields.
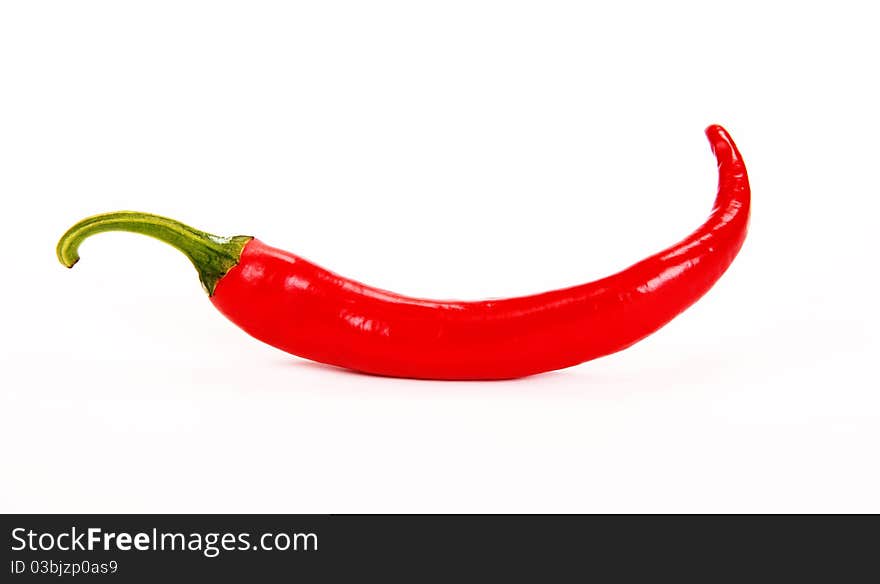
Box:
left=58, top=126, right=750, bottom=379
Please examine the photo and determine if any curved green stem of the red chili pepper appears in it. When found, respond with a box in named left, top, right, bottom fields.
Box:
left=56, top=211, right=253, bottom=296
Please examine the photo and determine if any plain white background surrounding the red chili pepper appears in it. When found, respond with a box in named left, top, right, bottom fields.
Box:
left=0, top=0, right=880, bottom=513
